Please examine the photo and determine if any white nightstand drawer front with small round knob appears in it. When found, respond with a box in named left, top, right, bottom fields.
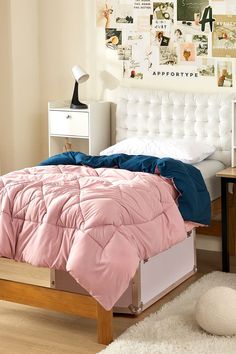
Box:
left=49, top=110, right=89, bottom=137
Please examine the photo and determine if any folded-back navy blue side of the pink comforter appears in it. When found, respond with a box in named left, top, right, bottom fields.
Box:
left=39, top=151, right=211, bottom=225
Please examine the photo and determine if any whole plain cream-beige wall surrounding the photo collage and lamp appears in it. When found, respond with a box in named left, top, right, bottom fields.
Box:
left=0, top=0, right=236, bottom=172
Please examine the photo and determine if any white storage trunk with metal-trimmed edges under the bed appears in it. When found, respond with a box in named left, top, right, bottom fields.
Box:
left=51, top=231, right=197, bottom=314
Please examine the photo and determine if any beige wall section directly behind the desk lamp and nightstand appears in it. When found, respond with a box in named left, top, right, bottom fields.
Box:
left=39, top=0, right=89, bottom=158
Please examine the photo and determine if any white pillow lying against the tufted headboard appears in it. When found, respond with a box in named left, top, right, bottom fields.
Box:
left=100, top=137, right=215, bottom=164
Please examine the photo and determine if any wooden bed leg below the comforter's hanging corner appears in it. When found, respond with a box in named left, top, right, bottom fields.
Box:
left=97, top=302, right=113, bottom=345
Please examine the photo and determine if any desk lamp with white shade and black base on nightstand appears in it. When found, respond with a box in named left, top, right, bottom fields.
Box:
left=70, top=65, right=89, bottom=109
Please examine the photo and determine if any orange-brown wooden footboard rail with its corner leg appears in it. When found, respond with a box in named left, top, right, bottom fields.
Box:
left=0, top=279, right=113, bottom=345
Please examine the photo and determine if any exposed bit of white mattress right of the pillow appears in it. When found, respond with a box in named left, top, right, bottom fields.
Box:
left=194, top=159, right=225, bottom=200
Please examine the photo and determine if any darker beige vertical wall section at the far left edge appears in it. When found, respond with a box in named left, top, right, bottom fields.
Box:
left=0, top=0, right=40, bottom=173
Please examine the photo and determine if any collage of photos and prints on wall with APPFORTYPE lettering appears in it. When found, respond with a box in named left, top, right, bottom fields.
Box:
left=97, top=0, right=236, bottom=87
